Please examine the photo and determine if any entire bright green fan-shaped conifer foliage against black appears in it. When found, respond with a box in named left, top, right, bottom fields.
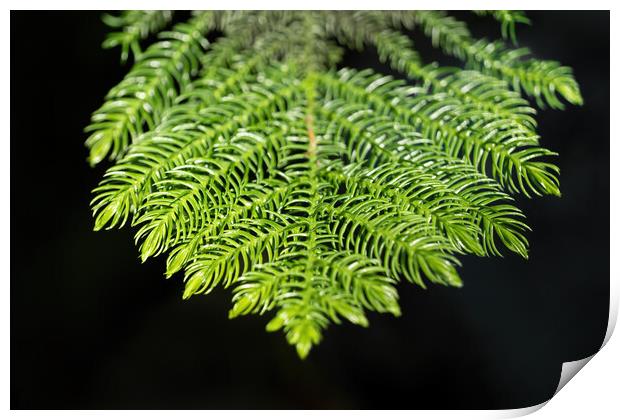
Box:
left=86, top=11, right=582, bottom=358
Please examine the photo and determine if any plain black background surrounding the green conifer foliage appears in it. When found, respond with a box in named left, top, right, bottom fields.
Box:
left=11, top=12, right=609, bottom=409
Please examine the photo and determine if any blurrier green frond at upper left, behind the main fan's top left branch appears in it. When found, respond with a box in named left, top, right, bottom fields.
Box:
left=86, top=12, right=213, bottom=165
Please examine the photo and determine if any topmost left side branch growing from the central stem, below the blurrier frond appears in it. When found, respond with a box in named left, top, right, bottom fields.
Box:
left=91, top=72, right=298, bottom=230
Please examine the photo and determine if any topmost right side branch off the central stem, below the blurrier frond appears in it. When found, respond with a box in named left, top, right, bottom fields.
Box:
left=324, top=72, right=559, bottom=196
